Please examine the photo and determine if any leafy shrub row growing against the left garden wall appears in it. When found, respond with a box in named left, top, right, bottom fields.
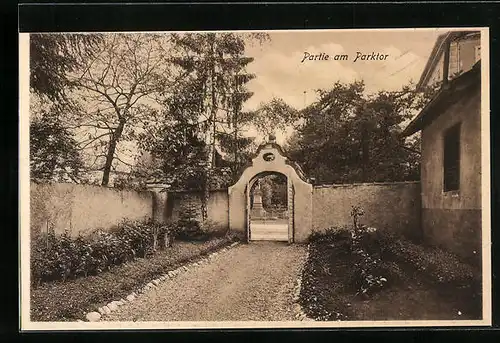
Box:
left=31, top=220, right=177, bottom=285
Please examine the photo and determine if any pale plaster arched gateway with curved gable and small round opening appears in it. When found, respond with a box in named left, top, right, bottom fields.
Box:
left=228, top=136, right=313, bottom=243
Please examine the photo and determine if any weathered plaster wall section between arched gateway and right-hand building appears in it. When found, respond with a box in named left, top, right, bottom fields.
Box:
left=313, top=182, right=421, bottom=238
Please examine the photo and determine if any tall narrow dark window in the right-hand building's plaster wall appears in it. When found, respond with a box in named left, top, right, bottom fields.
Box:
left=443, top=124, right=460, bottom=192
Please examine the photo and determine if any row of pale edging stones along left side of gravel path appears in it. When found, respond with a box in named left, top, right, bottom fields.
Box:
left=78, top=242, right=239, bottom=322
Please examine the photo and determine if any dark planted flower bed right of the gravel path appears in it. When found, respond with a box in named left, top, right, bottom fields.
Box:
left=300, top=208, right=481, bottom=320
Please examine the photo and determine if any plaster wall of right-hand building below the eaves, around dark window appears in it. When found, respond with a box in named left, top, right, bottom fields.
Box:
left=421, top=87, right=481, bottom=261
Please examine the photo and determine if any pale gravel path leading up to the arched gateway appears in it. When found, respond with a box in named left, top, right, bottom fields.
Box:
left=103, top=242, right=305, bottom=321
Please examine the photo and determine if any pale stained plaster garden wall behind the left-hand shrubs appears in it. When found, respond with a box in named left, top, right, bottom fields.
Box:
left=30, top=183, right=152, bottom=235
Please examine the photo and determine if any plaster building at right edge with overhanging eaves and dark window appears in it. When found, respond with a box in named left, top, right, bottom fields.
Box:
left=403, top=32, right=482, bottom=265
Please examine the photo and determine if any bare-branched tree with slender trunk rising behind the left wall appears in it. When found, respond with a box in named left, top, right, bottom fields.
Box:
left=67, top=33, right=181, bottom=185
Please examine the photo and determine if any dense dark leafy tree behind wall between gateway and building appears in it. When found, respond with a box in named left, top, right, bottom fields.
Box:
left=286, top=82, right=438, bottom=183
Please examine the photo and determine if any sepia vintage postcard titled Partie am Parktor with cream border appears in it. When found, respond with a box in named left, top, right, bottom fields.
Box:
left=19, top=28, right=491, bottom=330
